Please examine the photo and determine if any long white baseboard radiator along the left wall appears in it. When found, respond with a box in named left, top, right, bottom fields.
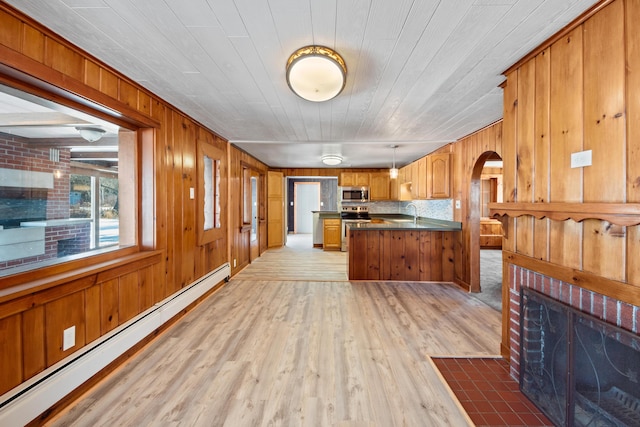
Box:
left=0, top=263, right=231, bottom=426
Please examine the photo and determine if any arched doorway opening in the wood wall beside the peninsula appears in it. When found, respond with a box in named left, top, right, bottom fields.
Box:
left=469, top=151, right=502, bottom=310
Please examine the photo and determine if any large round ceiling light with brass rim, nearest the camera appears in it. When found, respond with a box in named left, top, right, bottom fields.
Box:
left=287, top=46, right=347, bottom=102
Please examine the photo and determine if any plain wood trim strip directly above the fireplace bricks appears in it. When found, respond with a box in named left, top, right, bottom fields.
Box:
left=502, top=251, right=640, bottom=306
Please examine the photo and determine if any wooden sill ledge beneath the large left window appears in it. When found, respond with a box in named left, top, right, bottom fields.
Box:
left=0, top=251, right=162, bottom=304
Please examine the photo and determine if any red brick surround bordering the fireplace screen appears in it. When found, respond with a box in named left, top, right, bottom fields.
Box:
left=508, top=265, right=640, bottom=378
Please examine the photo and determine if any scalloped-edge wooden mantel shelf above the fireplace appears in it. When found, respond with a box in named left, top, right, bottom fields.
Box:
left=489, top=202, right=640, bottom=230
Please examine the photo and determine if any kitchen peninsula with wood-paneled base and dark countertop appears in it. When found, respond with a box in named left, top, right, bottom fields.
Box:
left=347, top=218, right=462, bottom=282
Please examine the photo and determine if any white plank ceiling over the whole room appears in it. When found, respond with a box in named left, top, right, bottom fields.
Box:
left=6, top=0, right=597, bottom=168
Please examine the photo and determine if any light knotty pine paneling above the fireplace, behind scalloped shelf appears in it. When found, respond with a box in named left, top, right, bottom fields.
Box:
left=504, top=0, right=640, bottom=305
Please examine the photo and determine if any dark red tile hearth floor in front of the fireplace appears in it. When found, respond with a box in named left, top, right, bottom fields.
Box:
left=432, top=357, right=553, bottom=427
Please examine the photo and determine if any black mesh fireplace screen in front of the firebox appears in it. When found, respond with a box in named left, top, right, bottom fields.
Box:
left=520, top=288, right=640, bottom=427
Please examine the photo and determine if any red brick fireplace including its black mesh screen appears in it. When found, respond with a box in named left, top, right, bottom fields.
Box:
left=506, top=264, right=640, bottom=427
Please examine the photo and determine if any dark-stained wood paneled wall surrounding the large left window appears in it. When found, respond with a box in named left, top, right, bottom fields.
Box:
left=0, top=3, right=230, bottom=394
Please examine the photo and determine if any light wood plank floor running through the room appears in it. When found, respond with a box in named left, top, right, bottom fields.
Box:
left=51, top=236, right=500, bottom=427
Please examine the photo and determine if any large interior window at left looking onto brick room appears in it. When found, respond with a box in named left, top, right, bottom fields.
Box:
left=0, top=86, right=136, bottom=276
